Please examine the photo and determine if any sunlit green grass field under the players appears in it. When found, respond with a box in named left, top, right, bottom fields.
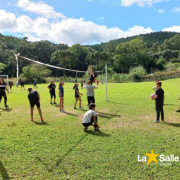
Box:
left=0, top=79, right=180, bottom=180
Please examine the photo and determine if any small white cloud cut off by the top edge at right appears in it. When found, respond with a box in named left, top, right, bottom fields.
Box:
left=121, top=0, right=168, bottom=7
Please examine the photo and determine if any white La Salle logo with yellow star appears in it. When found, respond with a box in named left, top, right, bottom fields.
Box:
left=138, top=150, right=179, bottom=165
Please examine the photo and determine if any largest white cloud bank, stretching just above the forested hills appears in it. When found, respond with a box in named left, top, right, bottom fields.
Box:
left=0, top=0, right=152, bottom=45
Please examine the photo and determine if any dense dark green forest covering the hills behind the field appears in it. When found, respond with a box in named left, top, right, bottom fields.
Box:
left=0, top=32, right=180, bottom=79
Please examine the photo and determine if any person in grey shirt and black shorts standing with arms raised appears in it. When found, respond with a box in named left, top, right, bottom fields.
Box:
left=84, top=80, right=98, bottom=105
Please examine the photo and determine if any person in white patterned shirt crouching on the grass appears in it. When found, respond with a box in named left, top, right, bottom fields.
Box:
left=82, top=103, right=100, bottom=132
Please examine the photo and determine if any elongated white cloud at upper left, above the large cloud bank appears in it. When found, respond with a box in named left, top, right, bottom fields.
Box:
left=17, top=0, right=66, bottom=19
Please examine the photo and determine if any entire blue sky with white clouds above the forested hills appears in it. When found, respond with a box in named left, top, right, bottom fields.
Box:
left=0, top=0, right=180, bottom=46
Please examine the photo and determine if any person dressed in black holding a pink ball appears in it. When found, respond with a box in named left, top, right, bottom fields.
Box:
left=153, top=82, right=164, bottom=123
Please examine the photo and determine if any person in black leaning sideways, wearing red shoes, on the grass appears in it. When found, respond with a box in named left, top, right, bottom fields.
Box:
left=28, top=88, right=43, bottom=121
